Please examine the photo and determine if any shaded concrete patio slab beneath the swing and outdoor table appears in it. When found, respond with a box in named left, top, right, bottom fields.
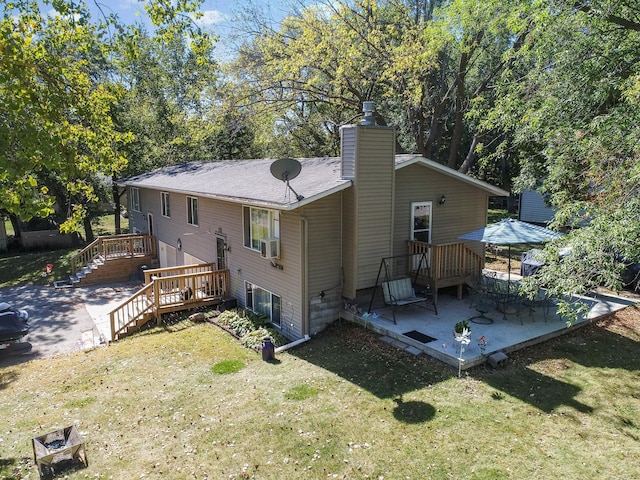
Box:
left=344, top=272, right=634, bottom=370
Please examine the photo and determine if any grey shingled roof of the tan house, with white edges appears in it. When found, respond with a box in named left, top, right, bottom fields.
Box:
left=118, top=155, right=508, bottom=206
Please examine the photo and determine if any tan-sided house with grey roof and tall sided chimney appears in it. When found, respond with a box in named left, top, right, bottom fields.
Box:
left=120, top=125, right=508, bottom=339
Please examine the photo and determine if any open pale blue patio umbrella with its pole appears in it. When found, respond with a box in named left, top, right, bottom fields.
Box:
left=458, top=218, right=562, bottom=292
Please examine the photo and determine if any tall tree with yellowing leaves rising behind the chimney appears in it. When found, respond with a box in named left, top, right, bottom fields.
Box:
left=238, top=0, right=531, bottom=181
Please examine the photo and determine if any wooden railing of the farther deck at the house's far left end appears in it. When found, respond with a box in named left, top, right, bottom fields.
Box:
left=71, top=234, right=156, bottom=275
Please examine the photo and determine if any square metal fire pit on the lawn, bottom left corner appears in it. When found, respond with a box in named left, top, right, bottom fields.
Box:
left=32, top=425, right=88, bottom=478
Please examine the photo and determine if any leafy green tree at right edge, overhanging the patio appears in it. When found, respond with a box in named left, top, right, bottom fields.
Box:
left=492, top=0, right=640, bottom=320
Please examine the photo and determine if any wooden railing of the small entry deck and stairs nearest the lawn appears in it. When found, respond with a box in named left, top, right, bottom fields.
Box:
left=109, top=264, right=229, bottom=340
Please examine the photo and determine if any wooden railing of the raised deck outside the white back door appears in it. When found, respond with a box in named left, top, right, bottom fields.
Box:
left=409, top=241, right=483, bottom=285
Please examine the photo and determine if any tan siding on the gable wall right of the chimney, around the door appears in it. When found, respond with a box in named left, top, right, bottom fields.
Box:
left=393, top=165, right=489, bottom=255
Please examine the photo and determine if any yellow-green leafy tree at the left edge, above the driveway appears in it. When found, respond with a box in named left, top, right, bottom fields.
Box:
left=0, top=0, right=129, bottom=230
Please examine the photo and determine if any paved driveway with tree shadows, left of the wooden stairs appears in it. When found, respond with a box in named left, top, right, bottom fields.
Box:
left=0, top=282, right=141, bottom=367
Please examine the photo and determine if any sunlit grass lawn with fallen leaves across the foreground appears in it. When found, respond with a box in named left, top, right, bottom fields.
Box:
left=0, top=308, right=640, bottom=480
